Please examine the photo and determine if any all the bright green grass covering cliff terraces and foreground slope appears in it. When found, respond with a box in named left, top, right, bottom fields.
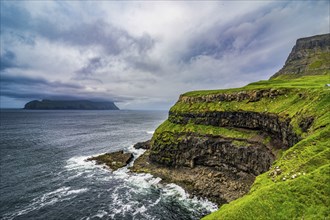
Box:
left=153, top=73, right=330, bottom=220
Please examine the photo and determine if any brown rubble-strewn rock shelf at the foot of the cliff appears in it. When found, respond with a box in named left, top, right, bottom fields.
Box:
left=131, top=150, right=255, bottom=205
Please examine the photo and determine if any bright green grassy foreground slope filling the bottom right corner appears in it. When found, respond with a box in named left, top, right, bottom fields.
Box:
left=203, top=128, right=330, bottom=220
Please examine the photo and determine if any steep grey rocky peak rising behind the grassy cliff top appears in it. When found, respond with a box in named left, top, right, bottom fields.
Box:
left=271, top=34, right=330, bottom=78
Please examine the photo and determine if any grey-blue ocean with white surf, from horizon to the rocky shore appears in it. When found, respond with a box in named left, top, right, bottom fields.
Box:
left=0, top=110, right=217, bottom=220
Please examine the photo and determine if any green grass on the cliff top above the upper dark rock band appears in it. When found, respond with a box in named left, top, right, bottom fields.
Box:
left=170, top=75, right=330, bottom=137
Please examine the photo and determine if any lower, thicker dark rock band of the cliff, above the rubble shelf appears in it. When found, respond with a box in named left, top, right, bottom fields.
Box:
left=150, top=133, right=275, bottom=175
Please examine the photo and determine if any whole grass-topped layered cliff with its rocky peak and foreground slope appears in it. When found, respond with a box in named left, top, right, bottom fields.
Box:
left=132, top=34, right=330, bottom=219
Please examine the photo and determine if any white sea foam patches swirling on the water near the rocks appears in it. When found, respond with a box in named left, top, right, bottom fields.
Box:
left=64, top=151, right=217, bottom=219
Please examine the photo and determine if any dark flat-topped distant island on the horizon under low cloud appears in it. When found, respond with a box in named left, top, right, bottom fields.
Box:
left=24, top=99, right=119, bottom=110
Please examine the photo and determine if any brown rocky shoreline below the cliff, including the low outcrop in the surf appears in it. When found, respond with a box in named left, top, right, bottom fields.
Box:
left=87, top=140, right=255, bottom=206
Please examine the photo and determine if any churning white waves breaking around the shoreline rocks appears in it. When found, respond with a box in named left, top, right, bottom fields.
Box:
left=62, top=152, right=217, bottom=219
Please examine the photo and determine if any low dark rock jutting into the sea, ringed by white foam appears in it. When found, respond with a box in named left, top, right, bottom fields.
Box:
left=87, top=150, right=134, bottom=171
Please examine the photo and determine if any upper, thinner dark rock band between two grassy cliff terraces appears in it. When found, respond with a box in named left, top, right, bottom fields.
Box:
left=169, top=111, right=300, bottom=149
